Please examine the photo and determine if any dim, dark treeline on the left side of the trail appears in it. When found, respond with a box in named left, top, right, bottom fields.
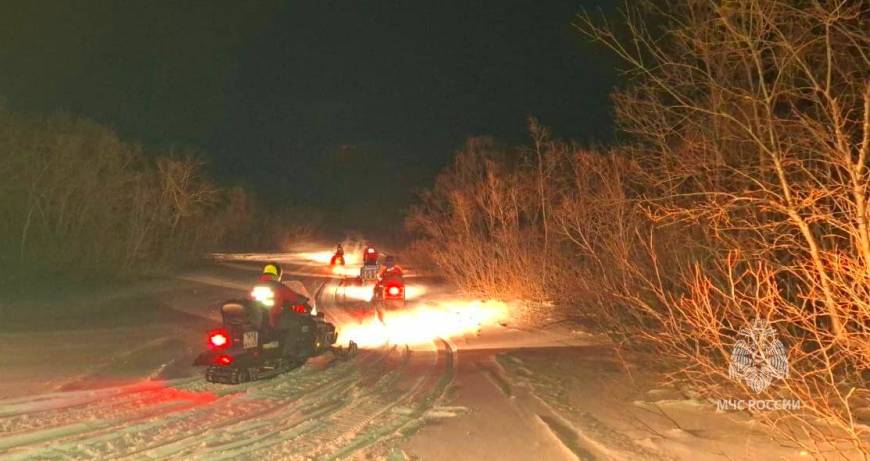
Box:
left=0, top=111, right=310, bottom=284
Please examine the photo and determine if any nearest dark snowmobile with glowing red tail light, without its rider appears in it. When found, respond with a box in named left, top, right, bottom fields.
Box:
left=194, top=299, right=357, bottom=384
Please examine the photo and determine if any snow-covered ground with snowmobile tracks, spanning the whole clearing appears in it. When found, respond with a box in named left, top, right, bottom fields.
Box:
left=0, top=248, right=832, bottom=460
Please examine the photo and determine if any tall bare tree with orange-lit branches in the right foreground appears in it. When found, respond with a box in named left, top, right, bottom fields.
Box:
left=578, top=0, right=870, bottom=458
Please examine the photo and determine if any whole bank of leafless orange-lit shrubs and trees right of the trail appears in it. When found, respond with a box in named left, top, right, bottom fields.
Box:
left=409, top=0, right=870, bottom=459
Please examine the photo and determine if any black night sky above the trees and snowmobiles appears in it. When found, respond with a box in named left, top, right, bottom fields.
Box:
left=0, top=0, right=618, bottom=234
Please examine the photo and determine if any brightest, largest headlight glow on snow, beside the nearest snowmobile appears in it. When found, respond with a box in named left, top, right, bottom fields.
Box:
left=339, top=301, right=508, bottom=347
